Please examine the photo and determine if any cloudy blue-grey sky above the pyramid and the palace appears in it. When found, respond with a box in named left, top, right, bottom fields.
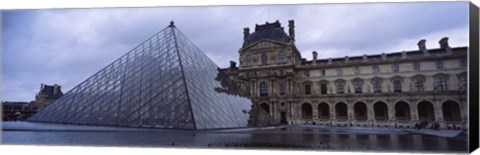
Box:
left=1, top=2, right=469, bottom=101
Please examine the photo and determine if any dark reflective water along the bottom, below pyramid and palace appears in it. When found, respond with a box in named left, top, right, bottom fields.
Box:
left=2, top=124, right=467, bottom=153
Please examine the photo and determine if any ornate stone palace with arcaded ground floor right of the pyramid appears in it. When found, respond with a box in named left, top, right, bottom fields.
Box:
left=225, top=20, right=468, bottom=128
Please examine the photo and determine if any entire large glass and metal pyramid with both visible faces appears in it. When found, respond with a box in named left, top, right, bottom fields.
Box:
left=29, top=22, right=252, bottom=129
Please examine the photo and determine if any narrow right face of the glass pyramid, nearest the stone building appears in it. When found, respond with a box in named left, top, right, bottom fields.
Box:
left=175, top=29, right=251, bottom=129
